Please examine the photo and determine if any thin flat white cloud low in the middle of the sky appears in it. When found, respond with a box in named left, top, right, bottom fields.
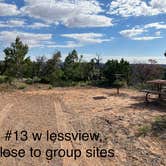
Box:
left=61, top=33, right=111, bottom=44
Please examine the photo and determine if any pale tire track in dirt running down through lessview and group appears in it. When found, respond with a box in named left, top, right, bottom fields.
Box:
left=54, top=100, right=103, bottom=166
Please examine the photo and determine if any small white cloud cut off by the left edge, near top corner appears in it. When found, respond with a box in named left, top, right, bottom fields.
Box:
left=0, top=2, right=20, bottom=16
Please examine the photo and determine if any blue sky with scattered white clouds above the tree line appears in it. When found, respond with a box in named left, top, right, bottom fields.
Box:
left=0, top=0, right=166, bottom=64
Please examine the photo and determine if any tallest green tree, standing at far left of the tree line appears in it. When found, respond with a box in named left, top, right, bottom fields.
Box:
left=4, top=37, right=28, bottom=78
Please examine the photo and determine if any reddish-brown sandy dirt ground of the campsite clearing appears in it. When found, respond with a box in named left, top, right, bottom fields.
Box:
left=0, top=88, right=166, bottom=166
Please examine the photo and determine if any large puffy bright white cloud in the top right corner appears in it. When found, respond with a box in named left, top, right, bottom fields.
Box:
left=109, top=0, right=166, bottom=17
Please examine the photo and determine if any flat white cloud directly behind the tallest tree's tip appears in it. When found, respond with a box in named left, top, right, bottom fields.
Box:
left=0, top=31, right=52, bottom=47
